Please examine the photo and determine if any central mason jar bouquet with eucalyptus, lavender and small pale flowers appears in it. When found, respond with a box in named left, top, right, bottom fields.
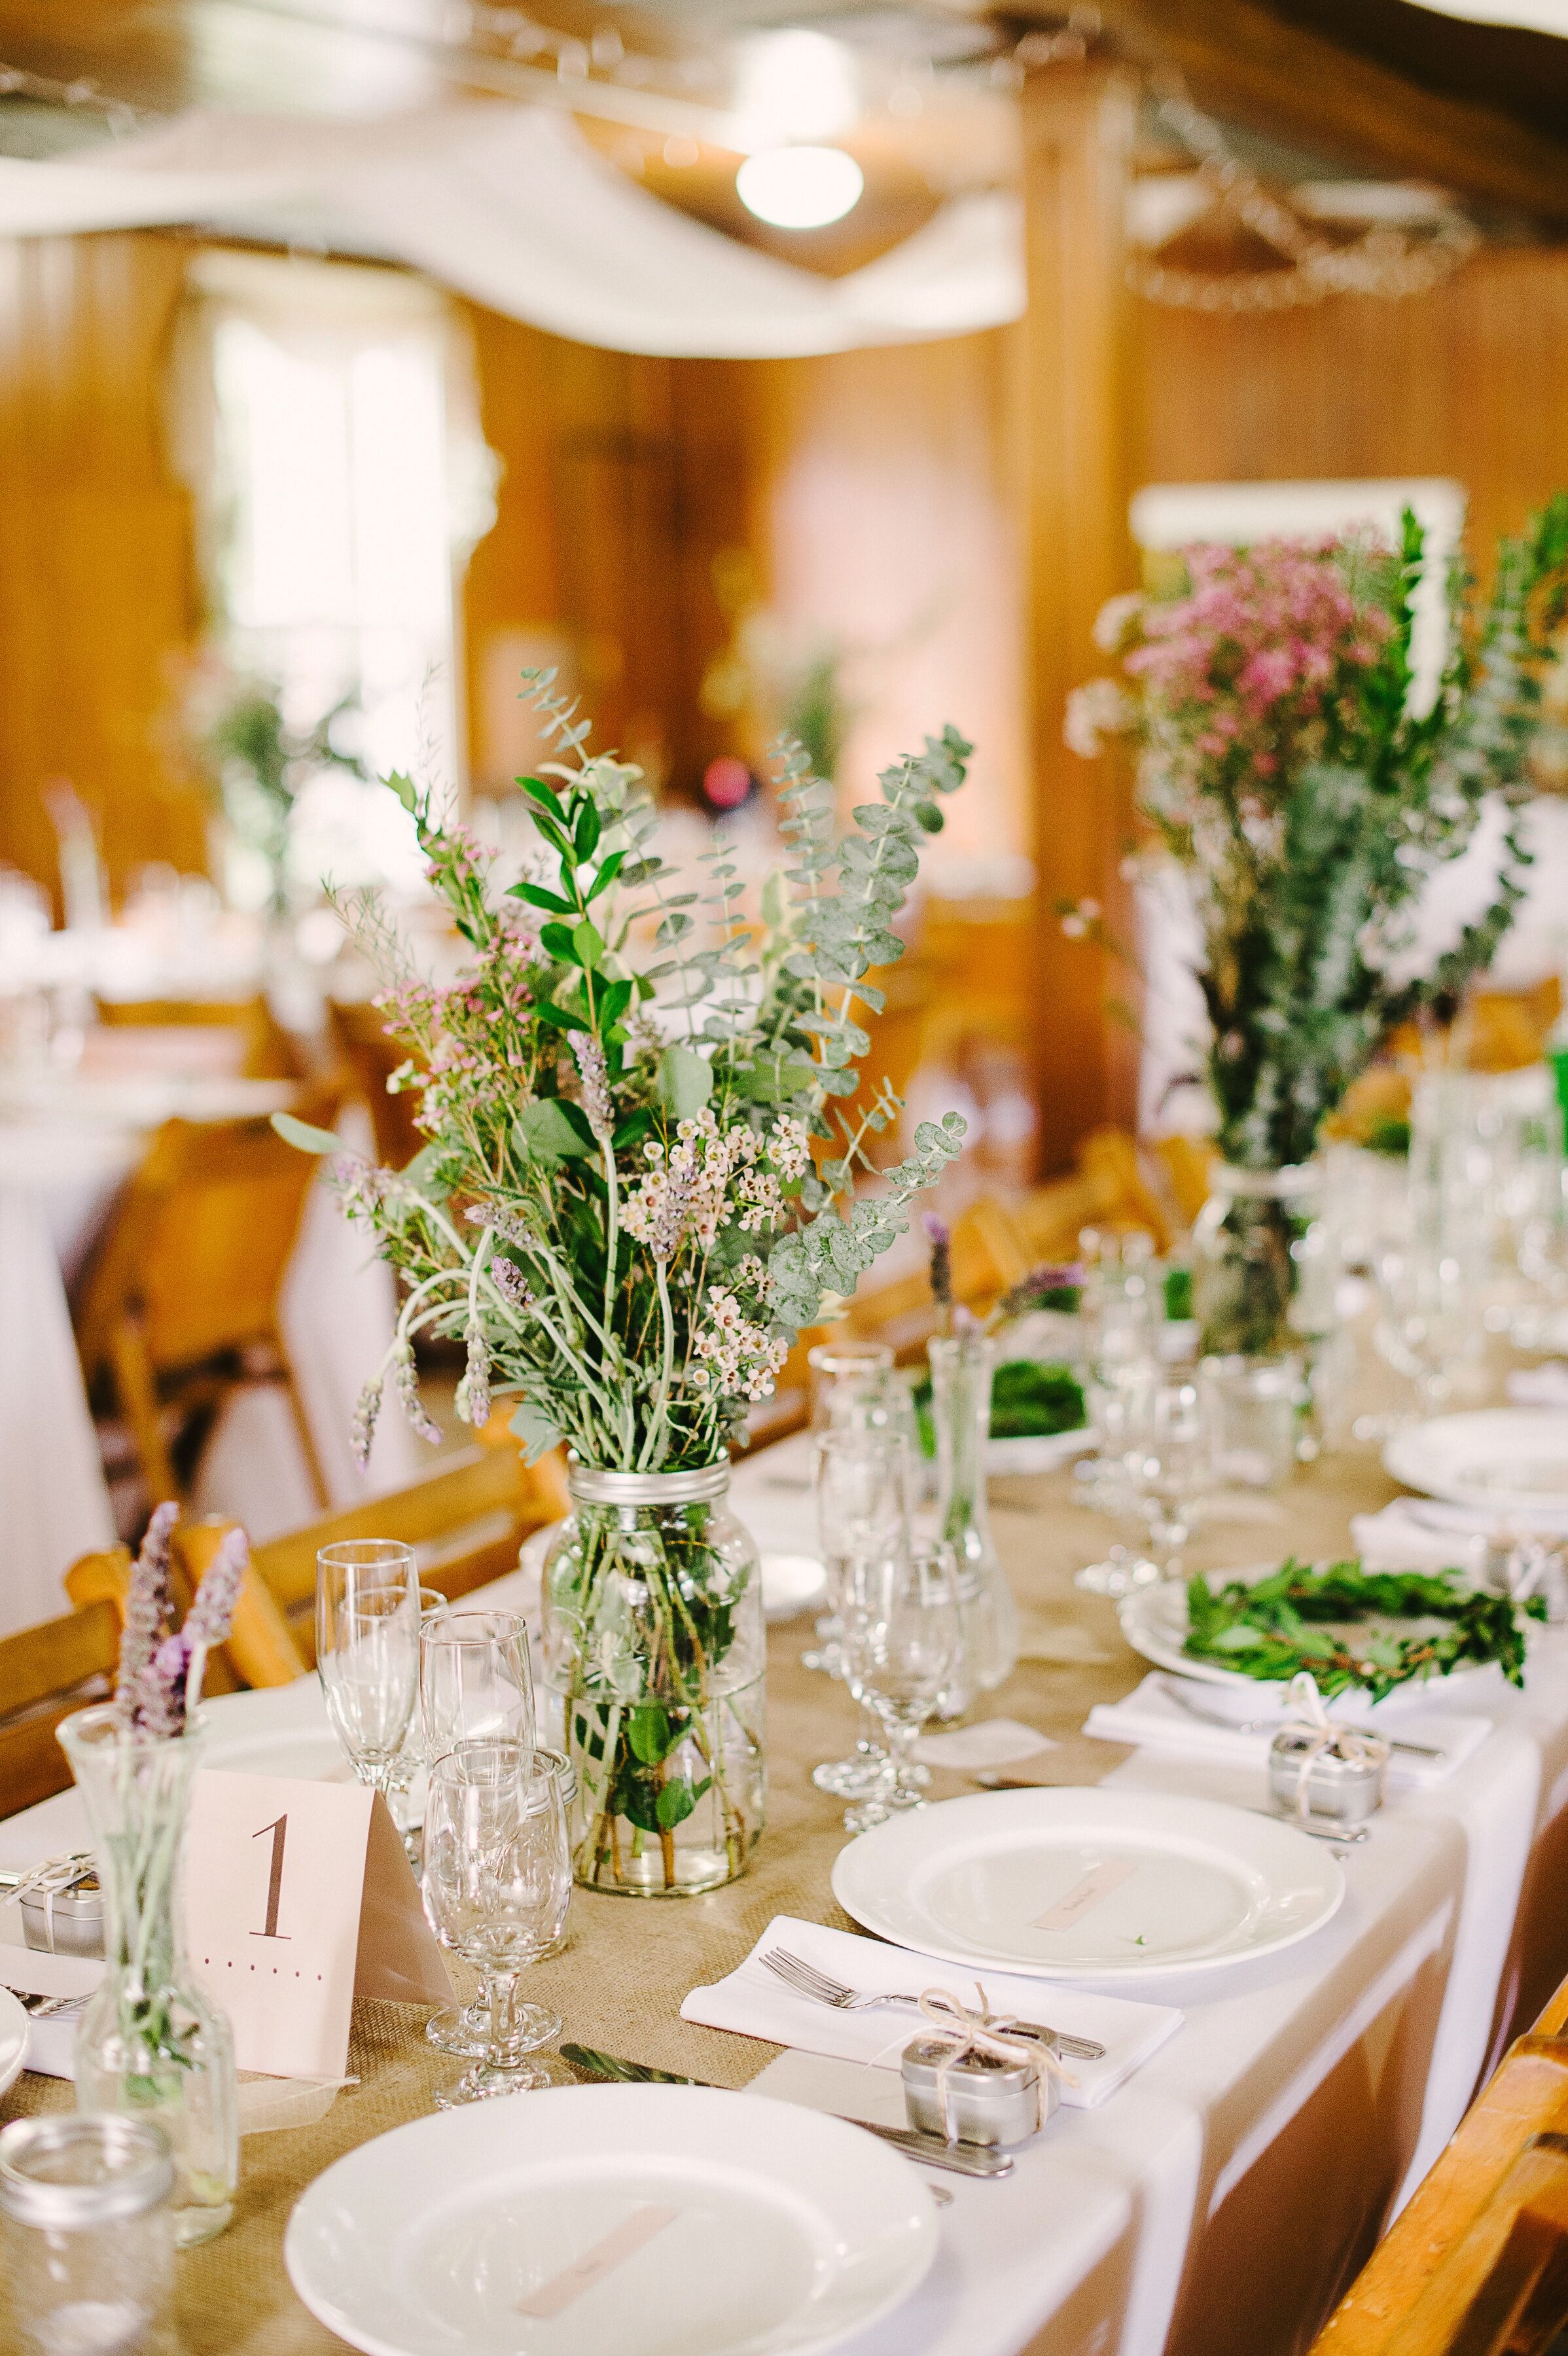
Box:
left=278, top=674, right=970, bottom=1894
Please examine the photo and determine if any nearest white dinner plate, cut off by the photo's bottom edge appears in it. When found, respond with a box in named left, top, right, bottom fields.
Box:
left=283, top=2085, right=937, bottom=2356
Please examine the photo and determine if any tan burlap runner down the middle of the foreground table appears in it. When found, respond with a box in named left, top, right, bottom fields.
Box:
left=0, top=1454, right=1394, bottom=2356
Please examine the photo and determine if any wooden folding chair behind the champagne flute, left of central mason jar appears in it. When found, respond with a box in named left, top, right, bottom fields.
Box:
left=198, top=1440, right=567, bottom=1685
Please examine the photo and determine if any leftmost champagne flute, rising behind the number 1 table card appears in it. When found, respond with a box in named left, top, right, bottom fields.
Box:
left=315, top=1539, right=419, bottom=1798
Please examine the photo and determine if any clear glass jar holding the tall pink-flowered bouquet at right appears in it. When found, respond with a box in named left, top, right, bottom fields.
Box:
left=1191, top=1162, right=1332, bottom=1357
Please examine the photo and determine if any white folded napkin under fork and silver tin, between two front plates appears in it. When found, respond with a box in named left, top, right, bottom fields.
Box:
left=681, top=1916, right=1182, bottom=2111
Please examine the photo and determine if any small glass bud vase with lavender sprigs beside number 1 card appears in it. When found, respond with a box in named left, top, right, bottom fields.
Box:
left=59, top=1505, right=249, bottom=2243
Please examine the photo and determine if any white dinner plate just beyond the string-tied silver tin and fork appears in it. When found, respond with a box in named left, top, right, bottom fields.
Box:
left=834, top=1788, right=1344, bottom=1982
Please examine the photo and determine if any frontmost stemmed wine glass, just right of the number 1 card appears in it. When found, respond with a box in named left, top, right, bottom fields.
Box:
left=424, top=1741, right=572, bottom=2111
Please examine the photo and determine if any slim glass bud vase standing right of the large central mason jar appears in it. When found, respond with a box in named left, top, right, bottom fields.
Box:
left=925, top=1334, right=1017, bottom=1705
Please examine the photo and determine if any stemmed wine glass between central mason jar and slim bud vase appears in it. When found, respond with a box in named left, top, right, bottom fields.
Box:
left=843, top=1546, right=963, bottom=1833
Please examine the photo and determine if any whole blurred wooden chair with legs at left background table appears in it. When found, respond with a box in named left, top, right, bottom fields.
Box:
left=75, top=1098, right=336, bottom=1503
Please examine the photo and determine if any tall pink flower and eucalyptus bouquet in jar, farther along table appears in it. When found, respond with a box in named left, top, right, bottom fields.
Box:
left=1067, top=495, right=1568, bottom=1352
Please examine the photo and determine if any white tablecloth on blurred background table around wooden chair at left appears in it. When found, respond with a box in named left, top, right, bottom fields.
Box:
left=0, top=1084, right=424, bottom=1635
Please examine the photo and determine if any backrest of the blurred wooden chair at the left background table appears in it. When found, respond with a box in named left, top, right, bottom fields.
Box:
left=78, top=1098, right=336, bottom=1381
